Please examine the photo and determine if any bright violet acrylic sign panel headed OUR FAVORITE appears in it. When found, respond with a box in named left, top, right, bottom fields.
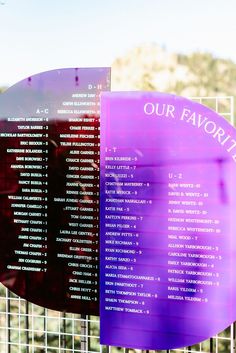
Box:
left=100, top=92, right=236, bottom=349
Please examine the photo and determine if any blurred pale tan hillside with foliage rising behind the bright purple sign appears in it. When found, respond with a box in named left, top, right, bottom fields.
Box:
left=112, top=43, right=236, bottom=112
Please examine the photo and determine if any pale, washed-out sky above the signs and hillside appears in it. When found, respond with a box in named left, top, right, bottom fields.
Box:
left=0, top=0, right=236, bottom=86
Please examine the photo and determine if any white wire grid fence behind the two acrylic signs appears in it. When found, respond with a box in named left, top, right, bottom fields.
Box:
left=0, top=97, right=236, bottom=353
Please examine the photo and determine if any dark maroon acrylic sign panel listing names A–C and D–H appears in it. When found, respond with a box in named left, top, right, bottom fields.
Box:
left=0, top=68, right=110, bottom=315
